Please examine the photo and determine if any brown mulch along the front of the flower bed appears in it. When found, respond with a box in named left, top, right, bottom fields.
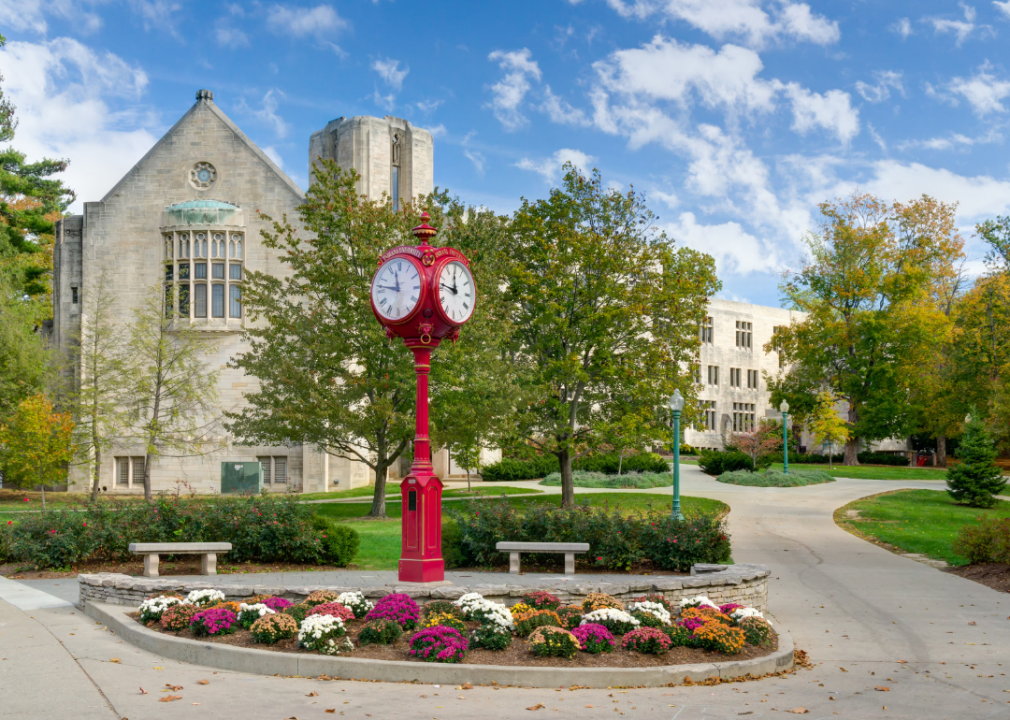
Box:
left=130, top=613, right=779, bottom=667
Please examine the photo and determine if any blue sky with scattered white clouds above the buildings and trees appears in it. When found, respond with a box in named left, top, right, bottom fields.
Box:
left=0, top=0, right=1010, bottom=306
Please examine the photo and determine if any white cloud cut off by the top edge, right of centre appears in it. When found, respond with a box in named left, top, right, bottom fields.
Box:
left=607, top=0, right=841, bottom=47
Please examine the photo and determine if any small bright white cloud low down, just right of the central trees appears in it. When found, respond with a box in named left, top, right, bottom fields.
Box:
left=660, top=212, right=780, bottom=275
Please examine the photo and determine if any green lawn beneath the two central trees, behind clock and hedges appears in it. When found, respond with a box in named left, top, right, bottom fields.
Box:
left=316, top=493, right=729, bottom=570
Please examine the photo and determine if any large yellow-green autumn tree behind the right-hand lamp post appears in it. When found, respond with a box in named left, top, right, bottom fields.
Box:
left=766, top=195, right=963, bottom=466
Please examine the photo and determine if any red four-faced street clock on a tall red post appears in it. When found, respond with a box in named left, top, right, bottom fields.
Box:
left=372, top=213, right=477, bottom=583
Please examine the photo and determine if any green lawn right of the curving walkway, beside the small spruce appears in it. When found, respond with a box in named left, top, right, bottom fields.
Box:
left=834, top=490, right=1010, bottom=564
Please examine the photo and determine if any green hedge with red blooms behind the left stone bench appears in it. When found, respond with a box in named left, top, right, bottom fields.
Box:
left=0, top=496, right=360, bottom=569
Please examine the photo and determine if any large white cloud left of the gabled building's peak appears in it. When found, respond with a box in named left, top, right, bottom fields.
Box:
left=0, top=37, right=158, bottom=212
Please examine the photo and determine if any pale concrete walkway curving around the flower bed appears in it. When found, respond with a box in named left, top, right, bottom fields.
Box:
left=0, top=467, right=1010, bottom=720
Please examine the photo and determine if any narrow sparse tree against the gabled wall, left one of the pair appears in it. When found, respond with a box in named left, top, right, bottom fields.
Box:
left=67, top=274, right=129, bottom=501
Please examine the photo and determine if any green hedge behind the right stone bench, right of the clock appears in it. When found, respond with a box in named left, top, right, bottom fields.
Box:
left=442, top=500, right=730, bottom=572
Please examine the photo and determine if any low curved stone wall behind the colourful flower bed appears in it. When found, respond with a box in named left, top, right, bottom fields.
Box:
left=78, top=564, right=770, bottom=612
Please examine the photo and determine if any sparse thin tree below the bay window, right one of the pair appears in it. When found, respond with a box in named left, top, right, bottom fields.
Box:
left=123, top=285, right=219, bottom=500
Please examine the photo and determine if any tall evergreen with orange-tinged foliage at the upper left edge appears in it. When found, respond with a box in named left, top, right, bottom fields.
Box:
left=0, top=35, right=75, bottom=304
